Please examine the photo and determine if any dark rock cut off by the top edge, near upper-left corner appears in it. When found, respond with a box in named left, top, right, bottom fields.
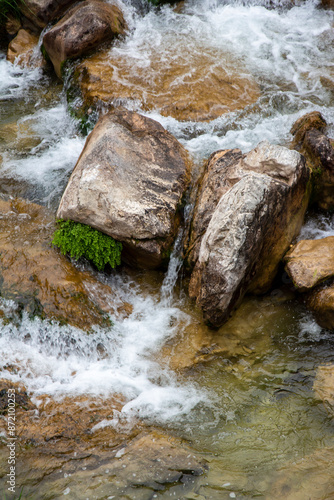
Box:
left=20, top=0, right=75, bottom=29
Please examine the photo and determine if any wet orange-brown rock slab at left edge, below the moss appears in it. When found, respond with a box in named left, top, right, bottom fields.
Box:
left=0, top=200, right=126, bottom=329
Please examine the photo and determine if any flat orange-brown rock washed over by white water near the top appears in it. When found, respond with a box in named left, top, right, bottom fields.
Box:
left=69, top=44, right=260, bottom=121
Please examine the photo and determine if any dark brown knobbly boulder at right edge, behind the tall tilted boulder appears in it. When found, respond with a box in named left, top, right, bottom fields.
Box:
left=291, top=111, right=334, bottom=210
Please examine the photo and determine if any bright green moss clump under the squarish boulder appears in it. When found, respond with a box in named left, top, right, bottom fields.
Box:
left=52, top=220, right=122, bottom=271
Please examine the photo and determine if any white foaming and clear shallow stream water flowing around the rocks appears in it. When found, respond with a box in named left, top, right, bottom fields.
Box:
left=0, top=0, right=334, bottom=500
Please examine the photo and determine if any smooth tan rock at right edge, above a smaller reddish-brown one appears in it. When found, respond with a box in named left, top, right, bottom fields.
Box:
left=284, top=236, right=334, bottom=292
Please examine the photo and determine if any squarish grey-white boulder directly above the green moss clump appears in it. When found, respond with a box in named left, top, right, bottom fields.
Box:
left=57, top=108, right=190, bottom=268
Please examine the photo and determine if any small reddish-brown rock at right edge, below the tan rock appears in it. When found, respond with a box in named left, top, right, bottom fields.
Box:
left=306, top=285, right=334, bottom=330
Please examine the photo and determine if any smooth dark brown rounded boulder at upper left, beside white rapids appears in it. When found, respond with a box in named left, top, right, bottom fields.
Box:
left=43, top=0, right=126, bottom=78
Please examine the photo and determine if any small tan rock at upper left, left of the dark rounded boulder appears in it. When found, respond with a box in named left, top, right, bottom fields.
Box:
left=7, top=29, right=46, bottom=67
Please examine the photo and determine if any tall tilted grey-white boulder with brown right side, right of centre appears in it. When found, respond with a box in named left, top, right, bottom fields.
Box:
left=189, top=141, right=309, bottom=327
